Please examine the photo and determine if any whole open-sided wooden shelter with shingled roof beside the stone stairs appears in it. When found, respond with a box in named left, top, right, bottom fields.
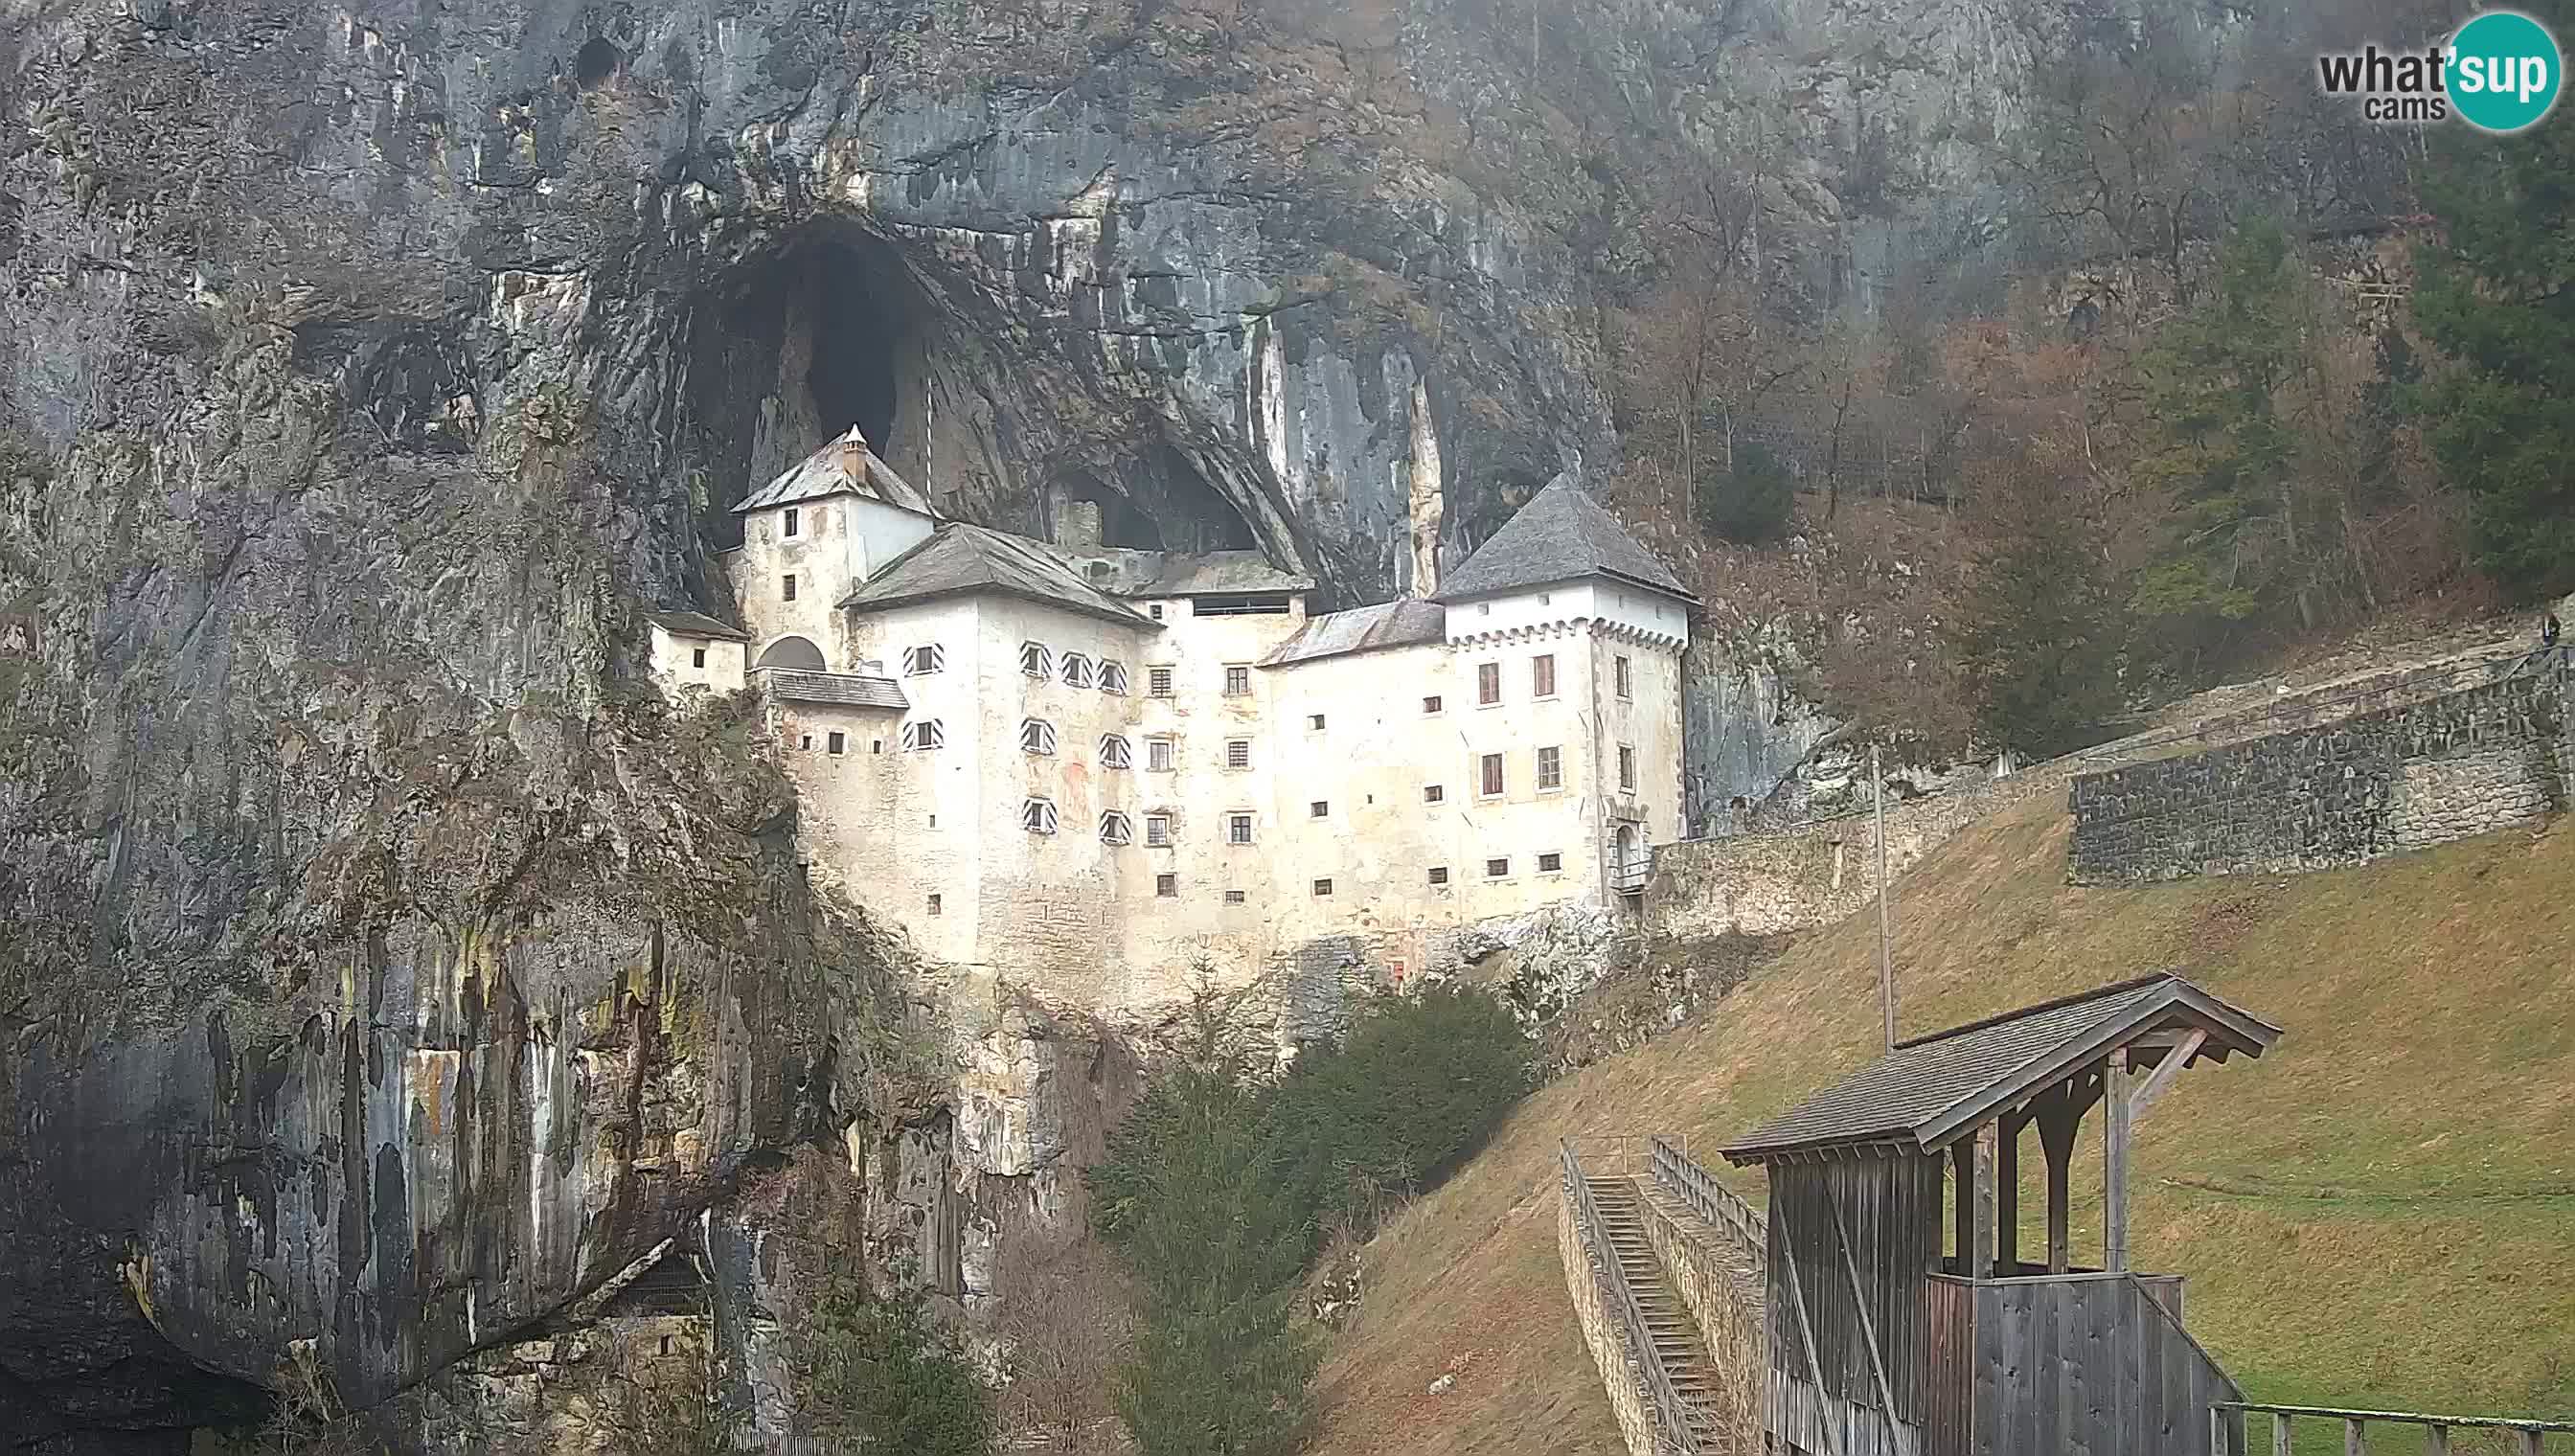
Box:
left=1722, top=974, right=2279, bottom=1456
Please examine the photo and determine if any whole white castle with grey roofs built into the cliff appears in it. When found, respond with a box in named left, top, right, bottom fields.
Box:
left=651, top=430, right=1692, bottom=1015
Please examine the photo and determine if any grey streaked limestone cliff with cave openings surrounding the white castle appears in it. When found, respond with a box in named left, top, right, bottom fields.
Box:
left=0, top=0, right=2379, bottom=1451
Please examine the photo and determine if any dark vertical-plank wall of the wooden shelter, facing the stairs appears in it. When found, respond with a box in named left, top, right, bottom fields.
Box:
left=1766, top=1157, right=1942, bottom=1425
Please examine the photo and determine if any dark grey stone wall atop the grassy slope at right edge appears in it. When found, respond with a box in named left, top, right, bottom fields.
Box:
left=2070, top=657, right=2575, bottom=884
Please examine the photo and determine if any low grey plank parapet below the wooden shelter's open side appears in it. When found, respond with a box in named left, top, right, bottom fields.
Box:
left=1934, top=1276, right=2243, bottom=1456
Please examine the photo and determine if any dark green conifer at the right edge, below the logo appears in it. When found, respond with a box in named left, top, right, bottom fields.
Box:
left=2413, top=31, right=2575, bottom=598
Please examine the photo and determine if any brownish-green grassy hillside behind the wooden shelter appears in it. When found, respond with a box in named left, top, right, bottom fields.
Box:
left=1318, top=799, right=2575, bottom=1456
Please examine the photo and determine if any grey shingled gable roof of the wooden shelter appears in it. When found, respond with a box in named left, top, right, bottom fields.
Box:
left=1720, top=974, right=2279, bottom=1162
